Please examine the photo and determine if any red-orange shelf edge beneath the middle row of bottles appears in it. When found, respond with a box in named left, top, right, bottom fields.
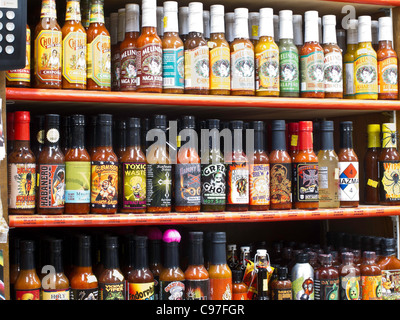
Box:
left=9, top=206, right=400, bottom=228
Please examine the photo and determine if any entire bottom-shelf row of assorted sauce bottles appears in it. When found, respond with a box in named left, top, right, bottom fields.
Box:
left=10, top=227, right=400, bottom=301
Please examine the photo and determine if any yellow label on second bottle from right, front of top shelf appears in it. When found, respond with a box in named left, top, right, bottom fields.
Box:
left=354, top=55, right=378, bottom=95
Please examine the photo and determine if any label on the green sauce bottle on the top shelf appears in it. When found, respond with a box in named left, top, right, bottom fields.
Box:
left=279, top=51, right=300, bottom=92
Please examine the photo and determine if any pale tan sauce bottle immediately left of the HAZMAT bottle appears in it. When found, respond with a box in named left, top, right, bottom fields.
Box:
left=318, top=121, right=340, bottom=208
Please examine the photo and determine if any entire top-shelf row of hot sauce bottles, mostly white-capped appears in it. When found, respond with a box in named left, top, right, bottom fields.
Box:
left=6, top=0, right=398, bottom=100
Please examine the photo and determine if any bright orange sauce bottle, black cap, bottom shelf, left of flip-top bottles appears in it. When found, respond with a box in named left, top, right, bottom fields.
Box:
left=208, top=232, right=232, bottom=300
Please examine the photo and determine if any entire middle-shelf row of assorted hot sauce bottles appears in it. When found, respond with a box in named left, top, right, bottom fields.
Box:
left=7, top=111, right=400, bottom=215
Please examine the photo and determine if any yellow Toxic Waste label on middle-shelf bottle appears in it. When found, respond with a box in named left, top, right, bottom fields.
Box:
left=122, top=162, right=146, bottom=209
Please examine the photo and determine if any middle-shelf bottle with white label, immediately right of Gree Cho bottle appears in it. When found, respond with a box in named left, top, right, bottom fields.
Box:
left=226, top=120, right=249, bottom=211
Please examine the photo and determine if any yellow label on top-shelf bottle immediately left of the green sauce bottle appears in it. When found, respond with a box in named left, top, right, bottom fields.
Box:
left=256, top=49, right=279, bottom=92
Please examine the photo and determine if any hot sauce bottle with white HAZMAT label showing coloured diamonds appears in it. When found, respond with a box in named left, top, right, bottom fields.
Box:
left=338, top=121, right=360, bottom=208
